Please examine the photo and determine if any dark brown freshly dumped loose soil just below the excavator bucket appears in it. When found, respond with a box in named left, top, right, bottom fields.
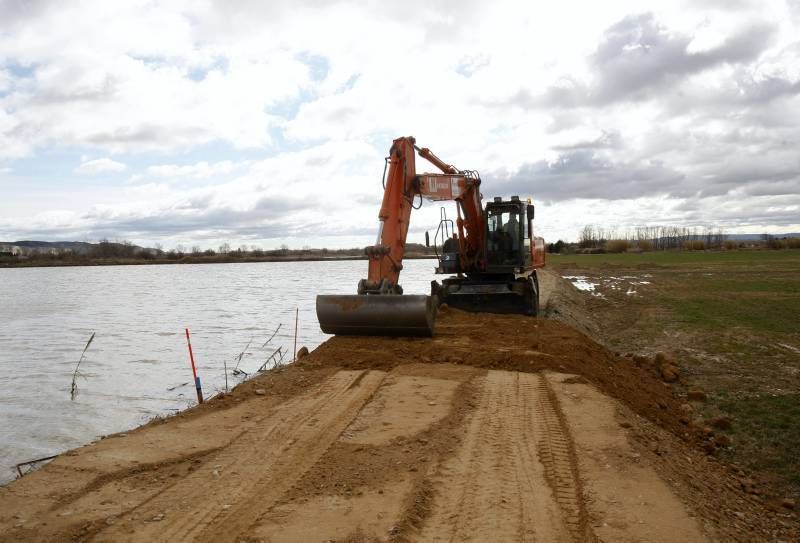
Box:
left=310, top=308, right=702, bottom=439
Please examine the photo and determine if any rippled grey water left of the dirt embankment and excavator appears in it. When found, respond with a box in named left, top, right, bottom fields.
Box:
left=0, top=260, right=435, bottom=482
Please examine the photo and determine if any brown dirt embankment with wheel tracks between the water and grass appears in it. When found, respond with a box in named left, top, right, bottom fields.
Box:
left=0, top=278, right=800, bottom=541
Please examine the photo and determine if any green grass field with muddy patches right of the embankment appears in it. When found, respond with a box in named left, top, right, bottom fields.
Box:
left=548, top=250, right=800, bottom=493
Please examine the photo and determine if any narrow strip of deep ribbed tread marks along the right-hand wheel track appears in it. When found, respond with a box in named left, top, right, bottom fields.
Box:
left=534, top=374, right=597, bottom=542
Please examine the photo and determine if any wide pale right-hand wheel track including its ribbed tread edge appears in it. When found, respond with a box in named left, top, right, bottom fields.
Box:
left=419, top=371, right=587, bottom=542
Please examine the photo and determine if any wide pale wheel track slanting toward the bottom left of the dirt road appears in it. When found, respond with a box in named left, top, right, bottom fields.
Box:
left=95, top=371, right=386, bottom=541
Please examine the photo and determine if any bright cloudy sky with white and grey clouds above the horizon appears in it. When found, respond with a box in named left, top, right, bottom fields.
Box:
left=0, top=0, right=800, bottom=247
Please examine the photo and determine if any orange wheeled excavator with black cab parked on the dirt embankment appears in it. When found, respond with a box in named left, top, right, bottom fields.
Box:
left=317, top=137, right=544, bottom=336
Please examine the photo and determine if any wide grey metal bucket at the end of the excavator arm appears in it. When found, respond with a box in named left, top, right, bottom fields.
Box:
left=317, top=294, right=438, bottom=337
